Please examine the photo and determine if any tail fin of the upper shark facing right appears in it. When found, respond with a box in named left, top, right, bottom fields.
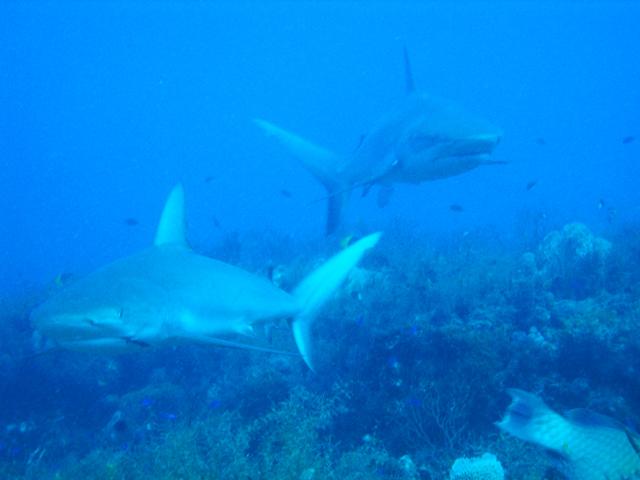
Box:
left=254, top=119, right=348, bottom=234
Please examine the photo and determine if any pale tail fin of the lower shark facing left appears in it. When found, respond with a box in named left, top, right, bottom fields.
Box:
left=292, top=233, right=381, bottom=370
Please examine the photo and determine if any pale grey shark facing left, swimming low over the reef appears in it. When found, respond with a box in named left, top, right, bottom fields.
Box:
left=31, top=185, right=381, bottom=370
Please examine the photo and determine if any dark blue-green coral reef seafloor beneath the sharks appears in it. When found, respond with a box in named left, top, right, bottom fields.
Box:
left=0, top=220, right=640, bottom=480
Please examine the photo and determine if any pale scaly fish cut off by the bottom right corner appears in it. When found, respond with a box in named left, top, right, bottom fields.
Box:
left=496, top=389, right=640, bottom=480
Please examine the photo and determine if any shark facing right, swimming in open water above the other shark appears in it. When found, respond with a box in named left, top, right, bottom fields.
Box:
left=254, top=49, right=505, bottom=234
